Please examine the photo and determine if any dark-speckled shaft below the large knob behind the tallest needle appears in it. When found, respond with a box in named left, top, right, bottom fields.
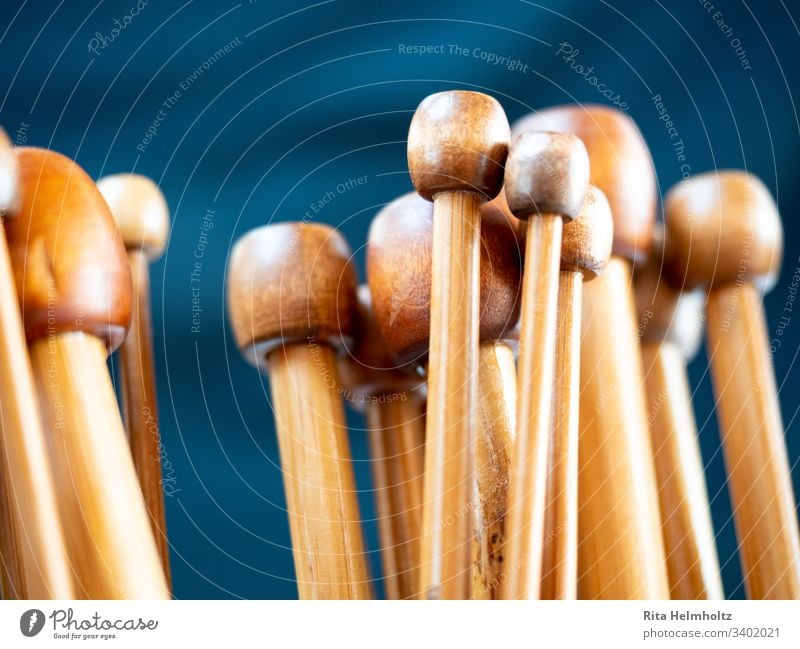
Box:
left=472, top=342, right=517, bottom=599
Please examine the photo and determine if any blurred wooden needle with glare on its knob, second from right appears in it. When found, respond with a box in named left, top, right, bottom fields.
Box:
left=634, top=229, right=724, bottom=599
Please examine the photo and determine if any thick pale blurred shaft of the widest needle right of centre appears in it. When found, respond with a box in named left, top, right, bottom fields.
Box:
left=578, top=257, right=669, bottom=599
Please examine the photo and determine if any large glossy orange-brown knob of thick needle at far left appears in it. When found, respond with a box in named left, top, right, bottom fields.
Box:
left=6, top=148, right=133, bottom=351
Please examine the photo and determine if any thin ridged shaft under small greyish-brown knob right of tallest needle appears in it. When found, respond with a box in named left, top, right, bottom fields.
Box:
left=503, top=214, right=562, bottom=599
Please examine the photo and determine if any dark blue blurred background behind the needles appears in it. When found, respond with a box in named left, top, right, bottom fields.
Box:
left=0, top=0, right=800, bottom=598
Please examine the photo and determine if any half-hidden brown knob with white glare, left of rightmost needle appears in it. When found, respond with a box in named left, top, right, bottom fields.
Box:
left=633, top=226, right=705, bottom=363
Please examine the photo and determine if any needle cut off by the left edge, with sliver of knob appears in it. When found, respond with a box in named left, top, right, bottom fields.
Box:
left=0, top=129, right=74, bottom=599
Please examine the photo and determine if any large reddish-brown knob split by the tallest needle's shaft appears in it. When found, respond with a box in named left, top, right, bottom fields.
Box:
left=367, top=194, right=522, bottom=364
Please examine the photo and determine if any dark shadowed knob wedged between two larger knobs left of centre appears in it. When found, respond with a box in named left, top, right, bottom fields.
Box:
left=339, top=284, right=423, bottom=410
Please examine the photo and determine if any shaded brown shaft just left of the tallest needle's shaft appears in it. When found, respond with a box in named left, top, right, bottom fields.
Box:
left=366, top=393, right=425, bottom=599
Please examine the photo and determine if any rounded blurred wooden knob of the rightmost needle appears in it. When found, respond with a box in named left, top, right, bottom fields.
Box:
left=664, top=171, right=783, bottom=290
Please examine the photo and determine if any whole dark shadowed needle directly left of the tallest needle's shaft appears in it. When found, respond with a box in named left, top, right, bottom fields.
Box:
left=339, top=285, right=425, bottom=599
